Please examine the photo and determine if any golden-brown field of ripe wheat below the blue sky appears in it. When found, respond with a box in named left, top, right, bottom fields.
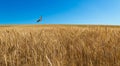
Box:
left=0, top=25, right=120, bottom=66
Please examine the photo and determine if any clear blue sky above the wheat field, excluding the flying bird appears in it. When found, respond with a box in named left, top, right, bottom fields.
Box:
left=0, top=0, right=120, bottom=25
